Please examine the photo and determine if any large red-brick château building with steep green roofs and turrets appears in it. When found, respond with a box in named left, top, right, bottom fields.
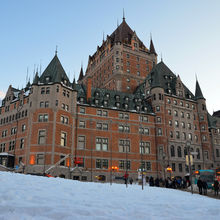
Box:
left=0, top=18, right=220, bottom=181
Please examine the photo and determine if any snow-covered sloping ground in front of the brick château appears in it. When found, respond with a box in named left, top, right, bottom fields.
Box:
left=0, top=172, right=220, bottom=220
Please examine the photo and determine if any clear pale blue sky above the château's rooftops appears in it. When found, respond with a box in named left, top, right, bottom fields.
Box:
left=0, top=0, right=220, bottom=113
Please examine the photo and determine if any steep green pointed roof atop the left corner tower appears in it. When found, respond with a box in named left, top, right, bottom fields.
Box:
left=39, top=54, right=70, bottom=84
